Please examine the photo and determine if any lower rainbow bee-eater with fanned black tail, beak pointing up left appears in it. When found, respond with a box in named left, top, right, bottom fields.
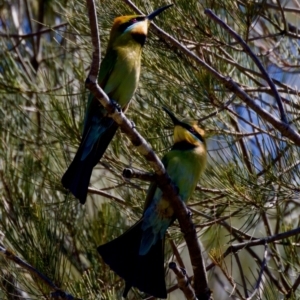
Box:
left=98, top=108, right=206, bottom=298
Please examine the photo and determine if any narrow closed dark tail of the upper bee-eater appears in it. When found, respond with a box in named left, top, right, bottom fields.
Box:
left=61, top=122, right=118, bottom=204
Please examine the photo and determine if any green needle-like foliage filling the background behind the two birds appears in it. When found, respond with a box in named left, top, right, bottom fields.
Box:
left=0, top=0, right=300, bottom=299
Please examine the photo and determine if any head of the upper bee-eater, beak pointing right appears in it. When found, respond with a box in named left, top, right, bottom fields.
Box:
left=109, top=4, right=173, bottom=47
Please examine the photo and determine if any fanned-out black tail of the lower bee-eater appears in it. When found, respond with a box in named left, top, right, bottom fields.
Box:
left=97, top=219, right=167, bottom=299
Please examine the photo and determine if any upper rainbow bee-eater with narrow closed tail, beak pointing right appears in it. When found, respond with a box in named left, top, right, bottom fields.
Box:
left=61, top=4, right=172, bottom=204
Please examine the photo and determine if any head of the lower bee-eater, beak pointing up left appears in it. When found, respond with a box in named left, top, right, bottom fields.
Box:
left=163, top=107, right=206, bottom=147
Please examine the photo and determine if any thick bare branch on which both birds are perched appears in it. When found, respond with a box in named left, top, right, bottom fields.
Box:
left=86, top=0, right=211, bottom=300
